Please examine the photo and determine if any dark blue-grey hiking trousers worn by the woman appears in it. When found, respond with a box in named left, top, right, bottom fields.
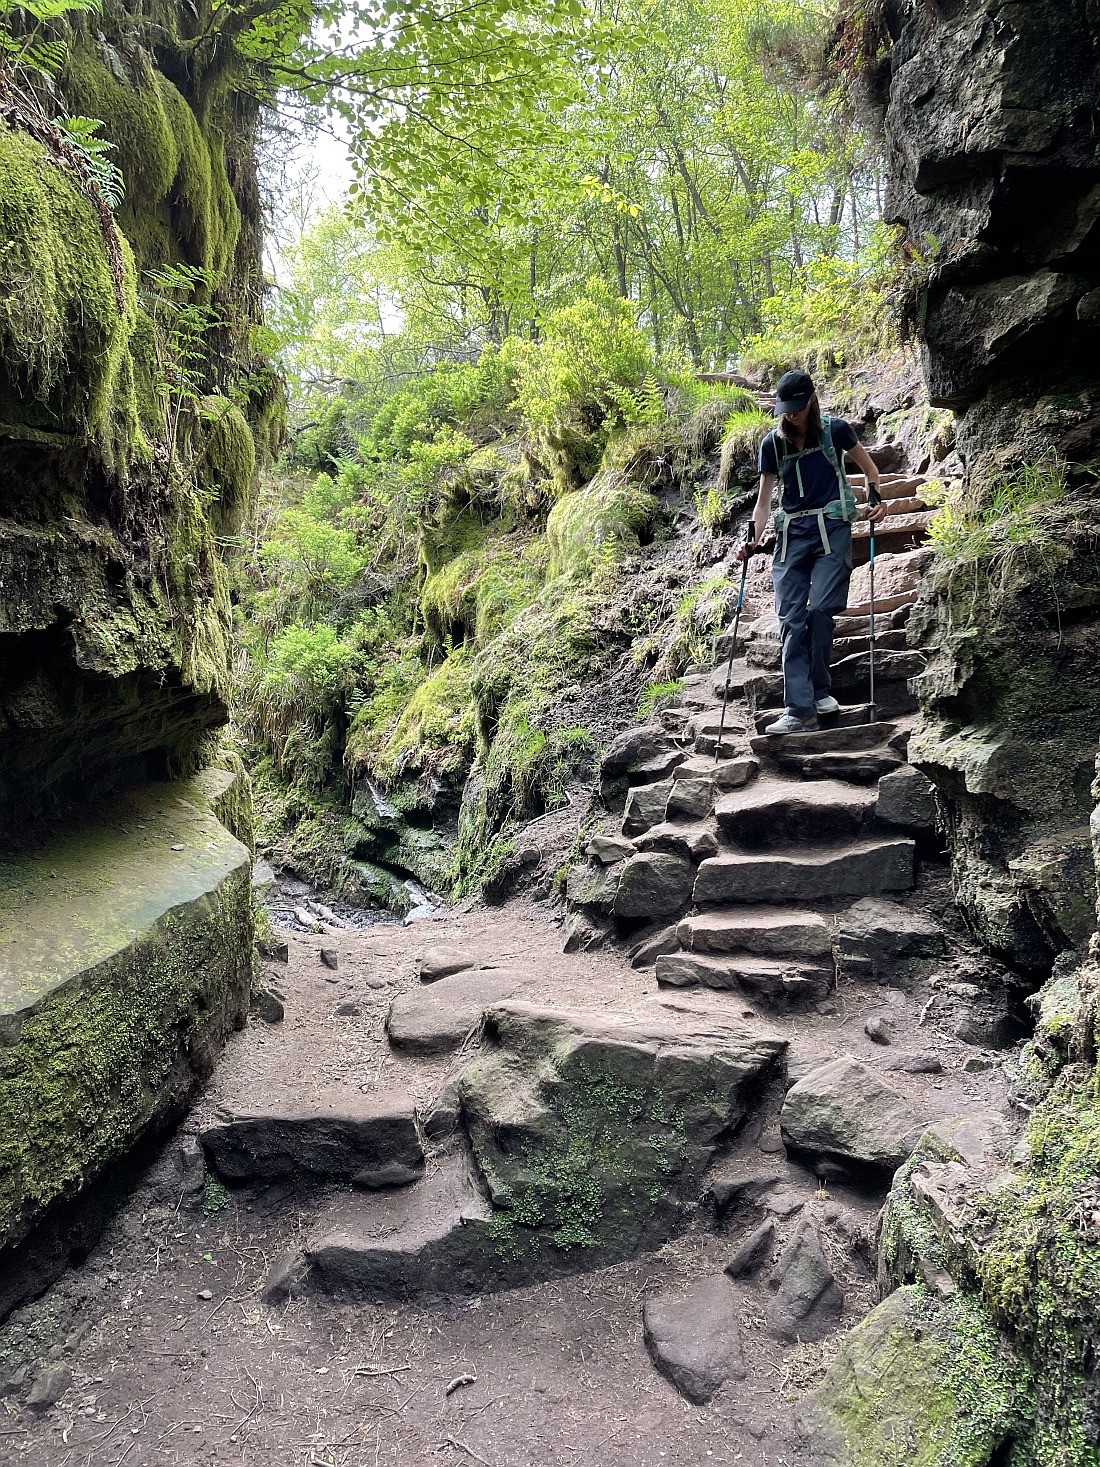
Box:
left=771, top=518, right=852, bottom=719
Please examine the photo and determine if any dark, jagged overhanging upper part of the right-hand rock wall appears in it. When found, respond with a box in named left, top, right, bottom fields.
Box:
left=886, top=0, right=1100, bottom=468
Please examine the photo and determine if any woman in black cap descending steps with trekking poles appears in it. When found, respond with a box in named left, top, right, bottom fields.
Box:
left=738, top=371, right=886, bottom=734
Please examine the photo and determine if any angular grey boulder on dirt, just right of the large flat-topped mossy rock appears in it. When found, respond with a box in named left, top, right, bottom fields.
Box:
left=780, top=1056, right=927, bottom=1171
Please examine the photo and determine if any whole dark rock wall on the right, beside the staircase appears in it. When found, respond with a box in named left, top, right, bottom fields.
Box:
left=879, top=0, right=1100, bottom=981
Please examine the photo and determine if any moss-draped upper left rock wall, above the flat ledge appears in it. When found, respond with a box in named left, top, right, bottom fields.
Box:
left=0, top=3, right=282, bottom=835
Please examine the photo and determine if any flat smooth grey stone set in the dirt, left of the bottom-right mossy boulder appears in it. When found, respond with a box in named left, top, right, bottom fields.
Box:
left=642, top=1273, right=747, bottom=1405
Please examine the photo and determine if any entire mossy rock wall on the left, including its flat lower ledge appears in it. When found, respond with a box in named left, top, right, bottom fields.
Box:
left=0, top=0, right=282, bottom=1314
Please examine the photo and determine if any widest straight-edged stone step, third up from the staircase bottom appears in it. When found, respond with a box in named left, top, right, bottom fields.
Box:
left=692, top=839, right=917, bottom=907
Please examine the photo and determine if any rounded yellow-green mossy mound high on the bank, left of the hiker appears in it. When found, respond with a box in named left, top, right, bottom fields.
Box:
left=546, top=472, right=660, bottom=579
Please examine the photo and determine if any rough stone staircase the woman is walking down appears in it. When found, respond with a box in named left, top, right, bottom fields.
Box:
left=568, top=460, right=933, bottom=1008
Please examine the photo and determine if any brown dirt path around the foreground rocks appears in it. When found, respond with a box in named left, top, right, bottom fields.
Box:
left=0, top=902, right=1003, bottom=1467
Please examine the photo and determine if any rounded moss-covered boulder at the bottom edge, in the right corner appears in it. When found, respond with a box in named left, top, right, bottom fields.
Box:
left=801, top=1288, right=1031, bottom=1467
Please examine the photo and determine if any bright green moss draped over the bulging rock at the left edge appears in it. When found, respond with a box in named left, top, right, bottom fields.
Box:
left=0, top=125, right=148, bottom=464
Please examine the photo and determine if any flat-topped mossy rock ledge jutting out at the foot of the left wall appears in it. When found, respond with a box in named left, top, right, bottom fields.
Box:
left=0, top=770, right=252, bottom=1309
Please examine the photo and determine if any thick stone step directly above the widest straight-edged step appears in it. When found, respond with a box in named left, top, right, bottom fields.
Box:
left=714, top=780, right=877, bottom=848
